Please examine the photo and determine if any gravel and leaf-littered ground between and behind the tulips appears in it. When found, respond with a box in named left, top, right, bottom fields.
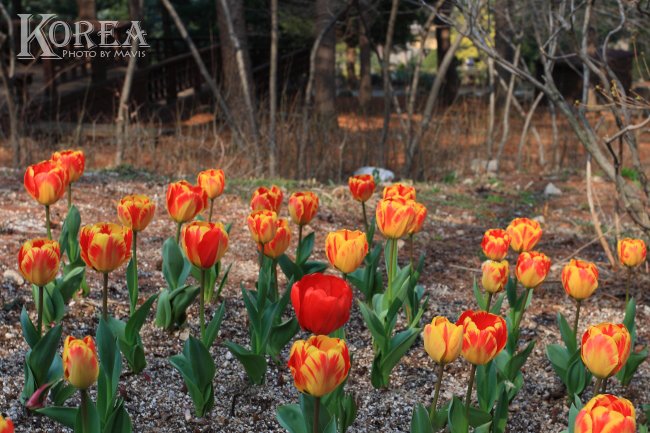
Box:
left=0, top=172, right=650, bottom=433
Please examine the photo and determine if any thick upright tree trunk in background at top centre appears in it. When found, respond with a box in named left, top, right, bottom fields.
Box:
left=314, top=0, right=336, bottom=120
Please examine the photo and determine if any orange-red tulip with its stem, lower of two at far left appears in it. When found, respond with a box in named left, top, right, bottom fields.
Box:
left=18, top=239, right=61, bottom=335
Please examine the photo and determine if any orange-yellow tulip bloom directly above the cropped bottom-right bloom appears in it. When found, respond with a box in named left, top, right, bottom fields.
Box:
left=580, top=323, right=632, bottom=379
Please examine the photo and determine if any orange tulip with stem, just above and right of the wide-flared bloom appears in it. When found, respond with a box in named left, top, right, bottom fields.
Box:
left=117, top=194, right=156, bottom=314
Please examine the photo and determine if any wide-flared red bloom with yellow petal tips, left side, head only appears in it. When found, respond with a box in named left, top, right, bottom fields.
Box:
left=79, top=223, right=133, bottom=273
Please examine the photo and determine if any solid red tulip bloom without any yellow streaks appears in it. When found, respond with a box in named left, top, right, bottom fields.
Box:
left=291, top=273, right=352, bottom=335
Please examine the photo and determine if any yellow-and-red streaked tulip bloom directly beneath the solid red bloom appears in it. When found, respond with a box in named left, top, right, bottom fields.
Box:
left=288, top=335, right=350, bottom=397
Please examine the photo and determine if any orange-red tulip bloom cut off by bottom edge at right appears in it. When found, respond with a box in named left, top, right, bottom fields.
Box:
left=574, top=394, right=636, bottom=433
